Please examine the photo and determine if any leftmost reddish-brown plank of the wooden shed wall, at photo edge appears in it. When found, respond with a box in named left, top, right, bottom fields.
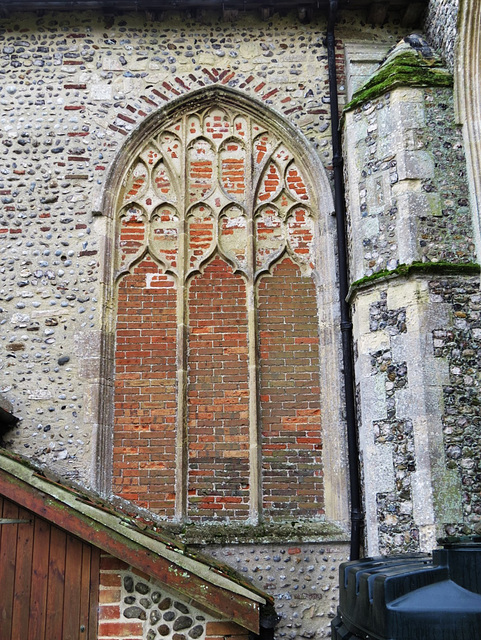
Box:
left=0, top=501, right=18, bottom=640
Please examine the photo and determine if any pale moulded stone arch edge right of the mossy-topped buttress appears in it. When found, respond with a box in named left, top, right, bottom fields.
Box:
left=455, top=0, right=481, bottom=261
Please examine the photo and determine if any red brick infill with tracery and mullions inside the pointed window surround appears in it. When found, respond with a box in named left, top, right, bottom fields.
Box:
left=113, top=105, right=323, bottom=522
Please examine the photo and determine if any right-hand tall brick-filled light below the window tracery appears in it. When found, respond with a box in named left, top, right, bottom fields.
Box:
left=258, top=258, right=323, bottom=518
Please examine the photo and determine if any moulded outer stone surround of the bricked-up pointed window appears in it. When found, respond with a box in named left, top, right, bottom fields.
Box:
left=97, top=87, right=347, bottom=522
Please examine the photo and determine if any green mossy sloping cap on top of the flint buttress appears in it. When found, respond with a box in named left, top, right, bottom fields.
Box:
left=344, top=49, right=453, bottom=112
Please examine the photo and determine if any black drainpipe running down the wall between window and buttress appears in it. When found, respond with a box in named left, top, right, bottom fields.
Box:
left=327, top=0, right=364, bottom=560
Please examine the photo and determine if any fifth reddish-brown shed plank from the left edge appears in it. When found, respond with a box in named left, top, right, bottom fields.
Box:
left=63, top=535, right=83, bottom=640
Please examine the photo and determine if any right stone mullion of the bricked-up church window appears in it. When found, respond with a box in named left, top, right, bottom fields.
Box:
left=246, top=128, right=262, bottom=523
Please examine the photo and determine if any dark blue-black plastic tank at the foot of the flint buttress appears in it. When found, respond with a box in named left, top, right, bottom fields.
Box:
left=331, top=538, right=481, bottom=640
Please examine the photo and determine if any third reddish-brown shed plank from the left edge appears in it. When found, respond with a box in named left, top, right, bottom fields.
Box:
left=28, top=518, right=51, bottom=640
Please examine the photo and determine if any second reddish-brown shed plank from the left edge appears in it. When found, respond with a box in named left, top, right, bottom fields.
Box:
left=12, top=509, right=34, bottom=638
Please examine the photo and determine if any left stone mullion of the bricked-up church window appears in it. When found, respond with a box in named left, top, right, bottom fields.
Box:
left=175, top=116, right=188, bottom=521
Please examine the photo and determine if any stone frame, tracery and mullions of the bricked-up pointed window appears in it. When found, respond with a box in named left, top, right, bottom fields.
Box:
left=91, top=85, right=347, bottom=522
